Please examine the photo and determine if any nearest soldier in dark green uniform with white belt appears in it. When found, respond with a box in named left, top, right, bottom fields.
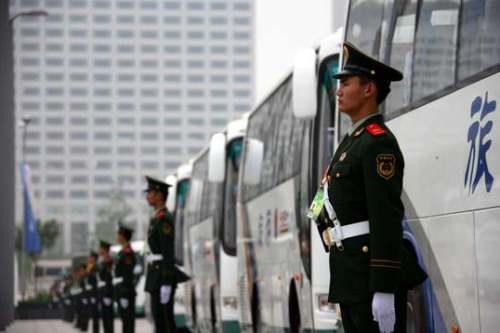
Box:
left=323, top=43, right=426, bottom=333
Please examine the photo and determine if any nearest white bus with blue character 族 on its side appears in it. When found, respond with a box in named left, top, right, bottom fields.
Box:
left=286, top=0, right=500, bottom=332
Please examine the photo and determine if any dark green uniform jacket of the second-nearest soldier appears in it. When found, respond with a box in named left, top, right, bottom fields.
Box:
left=145, top=208, right=175, bottom=292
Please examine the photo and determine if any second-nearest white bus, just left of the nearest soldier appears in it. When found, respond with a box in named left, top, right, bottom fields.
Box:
left=237, top=32, right=342, bottom=332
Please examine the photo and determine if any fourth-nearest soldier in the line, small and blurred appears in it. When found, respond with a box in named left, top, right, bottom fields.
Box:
left=99, top=241, right=114, bottom=333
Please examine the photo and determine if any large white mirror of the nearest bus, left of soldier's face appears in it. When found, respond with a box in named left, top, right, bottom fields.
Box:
left=292, top=48, right=316, bottom=118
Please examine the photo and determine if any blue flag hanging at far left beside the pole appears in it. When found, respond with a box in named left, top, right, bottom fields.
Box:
left=20, top=163, right=40, bottom=253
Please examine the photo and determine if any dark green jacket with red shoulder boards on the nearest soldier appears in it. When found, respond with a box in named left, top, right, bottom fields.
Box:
left=327, top=115, right=425, bottom=303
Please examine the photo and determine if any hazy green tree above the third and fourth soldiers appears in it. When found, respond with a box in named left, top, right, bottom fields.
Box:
left=96, top=187, right=132, bottom=241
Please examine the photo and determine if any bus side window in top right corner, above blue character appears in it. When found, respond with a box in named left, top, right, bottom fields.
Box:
left=458, top=0, right=500, bottom=80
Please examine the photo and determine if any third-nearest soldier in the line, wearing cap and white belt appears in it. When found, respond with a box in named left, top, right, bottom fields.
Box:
left=115, top=225, right=136, bottom=333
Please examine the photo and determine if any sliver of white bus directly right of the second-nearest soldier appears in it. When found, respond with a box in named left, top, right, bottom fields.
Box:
left=166, top=164, right=192, bottom=329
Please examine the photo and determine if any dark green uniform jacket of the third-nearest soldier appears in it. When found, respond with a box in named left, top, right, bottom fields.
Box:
left=115, top=244, right=135, bottom=298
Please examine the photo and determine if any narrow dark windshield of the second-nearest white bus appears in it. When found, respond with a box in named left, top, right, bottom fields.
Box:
left=222, top=138, right=243, bottom=255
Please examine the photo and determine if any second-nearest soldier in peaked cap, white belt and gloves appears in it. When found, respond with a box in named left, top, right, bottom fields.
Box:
left=145, top=176, right=176, bottom=333
